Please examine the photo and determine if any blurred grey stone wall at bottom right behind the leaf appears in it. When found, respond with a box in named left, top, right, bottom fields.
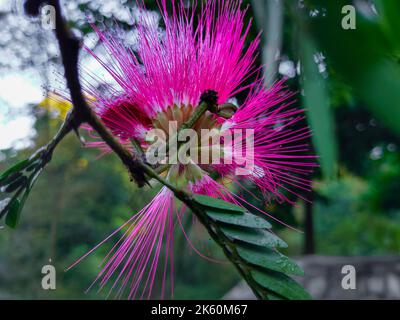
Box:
left=224, top=256, right=400, bottom=300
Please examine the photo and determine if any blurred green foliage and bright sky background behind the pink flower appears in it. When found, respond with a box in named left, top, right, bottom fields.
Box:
left=0, top=0, right=400, bottom=299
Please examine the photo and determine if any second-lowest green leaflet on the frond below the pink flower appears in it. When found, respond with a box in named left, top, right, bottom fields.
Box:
left=237, top=246, right=304, bottom=276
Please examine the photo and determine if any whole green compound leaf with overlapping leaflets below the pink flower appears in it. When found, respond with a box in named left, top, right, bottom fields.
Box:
left=194, top=196, right=310, bottom=300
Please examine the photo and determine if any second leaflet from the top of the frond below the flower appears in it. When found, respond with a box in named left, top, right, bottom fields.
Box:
left=207, top=210, right=271, bottom=229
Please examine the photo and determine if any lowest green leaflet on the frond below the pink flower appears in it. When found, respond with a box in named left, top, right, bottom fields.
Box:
left=251, top=270, right=311, bottom=300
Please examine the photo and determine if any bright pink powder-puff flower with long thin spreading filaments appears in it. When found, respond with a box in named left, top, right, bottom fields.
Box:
left=68, top=0, right=316, bottom=299
